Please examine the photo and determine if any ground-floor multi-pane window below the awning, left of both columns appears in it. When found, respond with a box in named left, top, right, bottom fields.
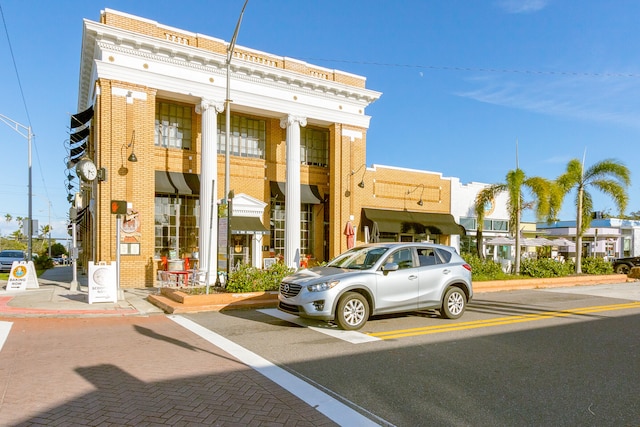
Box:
left=154, top=194, right=200, bottom=258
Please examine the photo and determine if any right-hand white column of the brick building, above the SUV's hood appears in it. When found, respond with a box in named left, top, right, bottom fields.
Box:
left=280, top=115, right=307, bottom=268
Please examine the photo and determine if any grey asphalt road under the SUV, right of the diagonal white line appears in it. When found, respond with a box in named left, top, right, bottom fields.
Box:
left=184, top=283, right=640, bottom=426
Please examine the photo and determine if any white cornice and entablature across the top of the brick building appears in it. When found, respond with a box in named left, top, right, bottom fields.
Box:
left=78, top=20, right=380, bottom=127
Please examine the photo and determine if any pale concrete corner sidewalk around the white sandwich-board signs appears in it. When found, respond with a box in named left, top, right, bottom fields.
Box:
left=0, top=266, right=164, bottom=317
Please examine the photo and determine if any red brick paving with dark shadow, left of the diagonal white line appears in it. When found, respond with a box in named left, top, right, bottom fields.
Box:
left=0, top=316, right=334, bottom=426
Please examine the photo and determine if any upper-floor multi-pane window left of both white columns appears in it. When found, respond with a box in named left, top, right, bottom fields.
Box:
left=155, top=102, right=192, bottom=150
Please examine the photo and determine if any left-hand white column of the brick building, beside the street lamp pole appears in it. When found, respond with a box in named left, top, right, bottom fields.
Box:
left=196, top=99, right=224, bottom=284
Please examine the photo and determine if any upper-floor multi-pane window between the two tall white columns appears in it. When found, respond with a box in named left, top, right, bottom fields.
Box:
left=218, top=114, right=267, bottom=159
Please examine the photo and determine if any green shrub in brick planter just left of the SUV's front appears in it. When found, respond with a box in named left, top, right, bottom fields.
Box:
left=226, top=263, right=294, bottom=293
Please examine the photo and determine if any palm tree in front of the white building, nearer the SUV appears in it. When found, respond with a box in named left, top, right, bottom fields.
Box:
left=474, top=168, right=561, bottom=274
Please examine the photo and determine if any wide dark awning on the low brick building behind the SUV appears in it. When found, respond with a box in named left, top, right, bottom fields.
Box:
left=362, top=208, right=467, bottom=236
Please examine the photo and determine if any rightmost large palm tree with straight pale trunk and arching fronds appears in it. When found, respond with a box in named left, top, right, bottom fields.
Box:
left=556, top=159, right=631, bottom=274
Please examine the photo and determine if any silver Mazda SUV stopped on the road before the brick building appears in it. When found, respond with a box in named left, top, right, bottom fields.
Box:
left=278, top=243, right=473, bottom=330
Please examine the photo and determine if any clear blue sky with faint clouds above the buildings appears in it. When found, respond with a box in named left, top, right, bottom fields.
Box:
left=0, top=0, right=640, bottom=237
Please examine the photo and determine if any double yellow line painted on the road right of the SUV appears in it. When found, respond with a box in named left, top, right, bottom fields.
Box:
left=368, top=301, right=640, bottom=340
